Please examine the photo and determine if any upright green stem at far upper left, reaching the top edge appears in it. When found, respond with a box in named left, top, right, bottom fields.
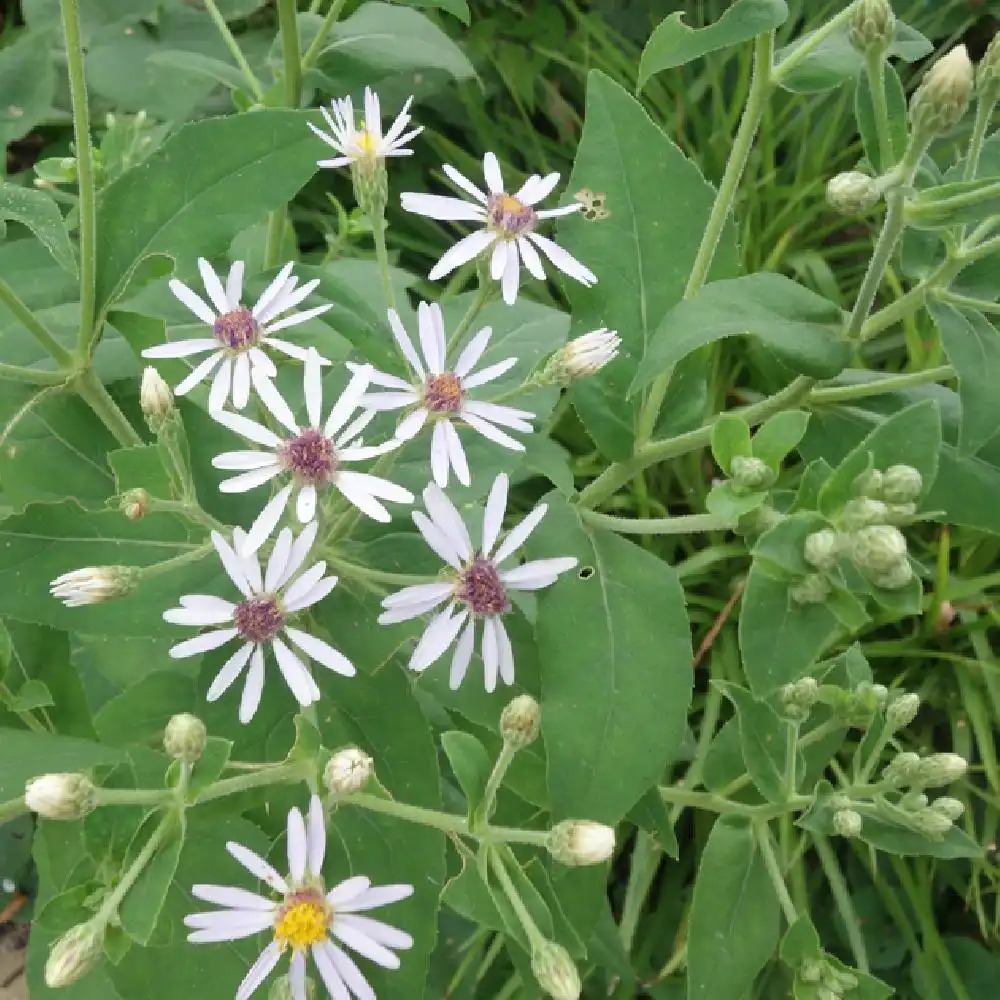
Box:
left=59, top=0, right=97, bottom=367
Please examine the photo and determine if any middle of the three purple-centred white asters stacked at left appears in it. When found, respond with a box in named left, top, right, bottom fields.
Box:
left=212, top=349, right=413, bottom=555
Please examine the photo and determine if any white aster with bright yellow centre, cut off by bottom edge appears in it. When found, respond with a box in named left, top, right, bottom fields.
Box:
left=184, top=795, right=413, bottom=1000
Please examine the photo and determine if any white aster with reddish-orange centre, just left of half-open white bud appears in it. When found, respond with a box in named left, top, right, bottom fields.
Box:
left=361, top=302, right=535, bottom=486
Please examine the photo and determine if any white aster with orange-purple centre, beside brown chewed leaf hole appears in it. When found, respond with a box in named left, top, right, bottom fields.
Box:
left=402, top=153, right=597, bottom=305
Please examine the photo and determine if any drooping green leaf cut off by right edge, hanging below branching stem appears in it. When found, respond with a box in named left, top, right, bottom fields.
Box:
left=927, top=302, right=1000, bottom=456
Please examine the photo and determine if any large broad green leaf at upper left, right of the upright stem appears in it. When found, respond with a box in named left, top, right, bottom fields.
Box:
left=97, top=108, right=317, bottom=314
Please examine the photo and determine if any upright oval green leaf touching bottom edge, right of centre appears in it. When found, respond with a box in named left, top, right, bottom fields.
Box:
left=688, top=816, right=780, bottom=1000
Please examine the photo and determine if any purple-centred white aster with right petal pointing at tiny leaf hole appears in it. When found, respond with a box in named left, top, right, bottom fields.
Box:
left=378, top=473, right=577, bottom=691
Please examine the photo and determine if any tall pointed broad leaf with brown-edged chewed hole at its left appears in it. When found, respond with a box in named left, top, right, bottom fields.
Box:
left=559, top=70, right=739, bottom=459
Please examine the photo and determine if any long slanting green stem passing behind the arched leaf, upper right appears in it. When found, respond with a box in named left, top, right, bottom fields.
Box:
left=636, top=32, right=774, bottom=440
